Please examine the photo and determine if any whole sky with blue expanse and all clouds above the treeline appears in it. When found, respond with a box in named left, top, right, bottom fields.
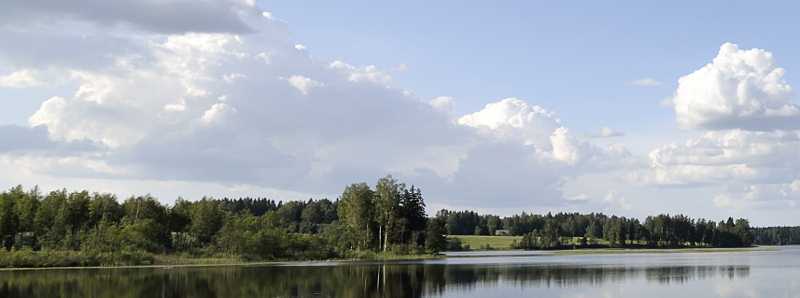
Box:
left=0, top=0, right=800, bottom=226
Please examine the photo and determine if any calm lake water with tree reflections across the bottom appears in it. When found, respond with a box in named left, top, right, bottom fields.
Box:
left=0, top=247, right=800, bottom=298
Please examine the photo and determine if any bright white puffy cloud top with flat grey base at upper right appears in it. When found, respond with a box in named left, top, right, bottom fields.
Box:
left=672, top=43, right=800, bottom=130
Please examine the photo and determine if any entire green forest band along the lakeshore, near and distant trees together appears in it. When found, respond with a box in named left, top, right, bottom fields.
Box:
left=0, top=176, right=797, bottom=267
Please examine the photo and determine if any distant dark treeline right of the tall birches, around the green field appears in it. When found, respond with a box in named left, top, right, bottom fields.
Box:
left=436, top=210, right=753, bottom=249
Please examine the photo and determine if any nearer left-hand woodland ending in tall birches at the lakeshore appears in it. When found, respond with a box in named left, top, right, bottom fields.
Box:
left=0, top=176, right=446, bottom=267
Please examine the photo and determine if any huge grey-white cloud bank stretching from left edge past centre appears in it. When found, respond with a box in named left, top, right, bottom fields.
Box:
left=0, top=4, right=629, bottom=210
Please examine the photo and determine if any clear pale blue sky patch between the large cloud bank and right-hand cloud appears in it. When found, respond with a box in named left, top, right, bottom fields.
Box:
left=263, top=1, right=800, bottom=139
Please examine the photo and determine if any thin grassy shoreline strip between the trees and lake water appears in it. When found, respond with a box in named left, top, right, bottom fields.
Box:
left=0, top=246, right=779, bottom=272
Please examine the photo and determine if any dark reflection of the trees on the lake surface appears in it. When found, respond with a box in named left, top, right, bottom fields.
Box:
left=0, top=264, right=750, bottom=298
